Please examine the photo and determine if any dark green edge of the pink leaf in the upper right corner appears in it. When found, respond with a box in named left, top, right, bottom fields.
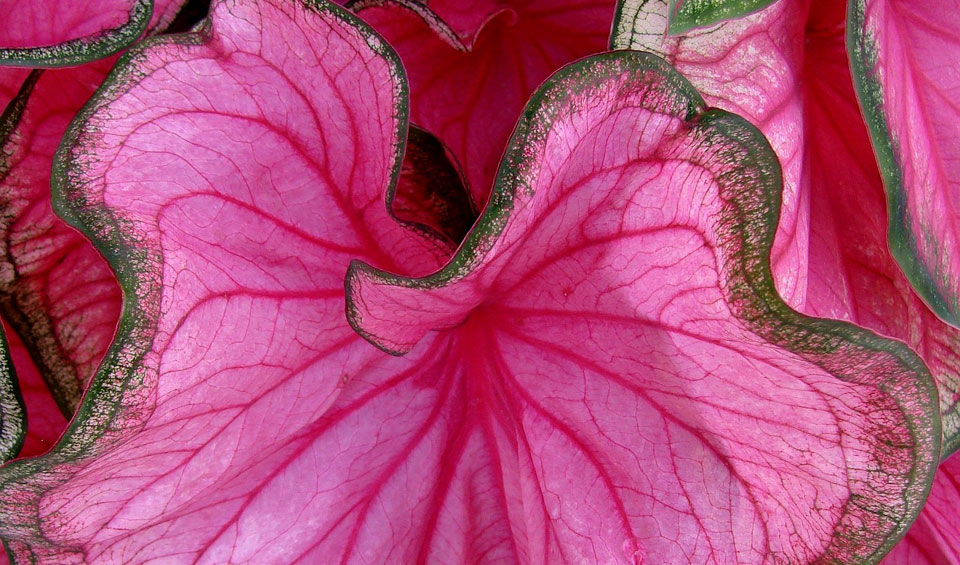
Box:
left=847, top=0, right=960, bottom=332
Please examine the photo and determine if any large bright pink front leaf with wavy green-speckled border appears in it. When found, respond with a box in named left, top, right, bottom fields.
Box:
left=0, top=0, right=940, bottom=563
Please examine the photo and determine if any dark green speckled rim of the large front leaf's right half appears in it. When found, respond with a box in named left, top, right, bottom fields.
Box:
left=346, top=51, right=940, bottom=563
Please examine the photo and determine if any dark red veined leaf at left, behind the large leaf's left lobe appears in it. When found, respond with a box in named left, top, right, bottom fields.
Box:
left=0, top=60, right=121, bottom=416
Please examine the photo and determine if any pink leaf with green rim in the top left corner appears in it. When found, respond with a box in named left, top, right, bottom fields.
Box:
left=0, top=0, right=153, bottom=67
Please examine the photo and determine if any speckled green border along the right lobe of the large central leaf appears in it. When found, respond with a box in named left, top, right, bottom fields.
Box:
left=345, top=50, right=941, bottom=563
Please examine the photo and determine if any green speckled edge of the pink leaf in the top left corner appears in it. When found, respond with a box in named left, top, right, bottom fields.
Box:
left=0, top=0, right=153, bottom=69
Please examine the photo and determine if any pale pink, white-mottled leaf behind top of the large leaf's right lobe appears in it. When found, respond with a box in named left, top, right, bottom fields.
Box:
left=610, top=0, right=810, bottom=308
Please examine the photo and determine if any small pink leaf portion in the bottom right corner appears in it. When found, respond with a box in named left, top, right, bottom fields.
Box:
left=882, top=457, right=960, bottom=565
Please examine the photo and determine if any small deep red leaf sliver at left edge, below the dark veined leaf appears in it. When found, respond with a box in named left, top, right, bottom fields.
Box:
left=3, top=318, right=67, bottom=457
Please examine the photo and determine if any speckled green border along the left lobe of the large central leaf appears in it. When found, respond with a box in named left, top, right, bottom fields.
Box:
left=0, top=0, right=414, bottom=563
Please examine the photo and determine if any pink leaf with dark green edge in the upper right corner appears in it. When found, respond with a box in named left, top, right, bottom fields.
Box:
left=847, top=0, right=960, bottom=327
